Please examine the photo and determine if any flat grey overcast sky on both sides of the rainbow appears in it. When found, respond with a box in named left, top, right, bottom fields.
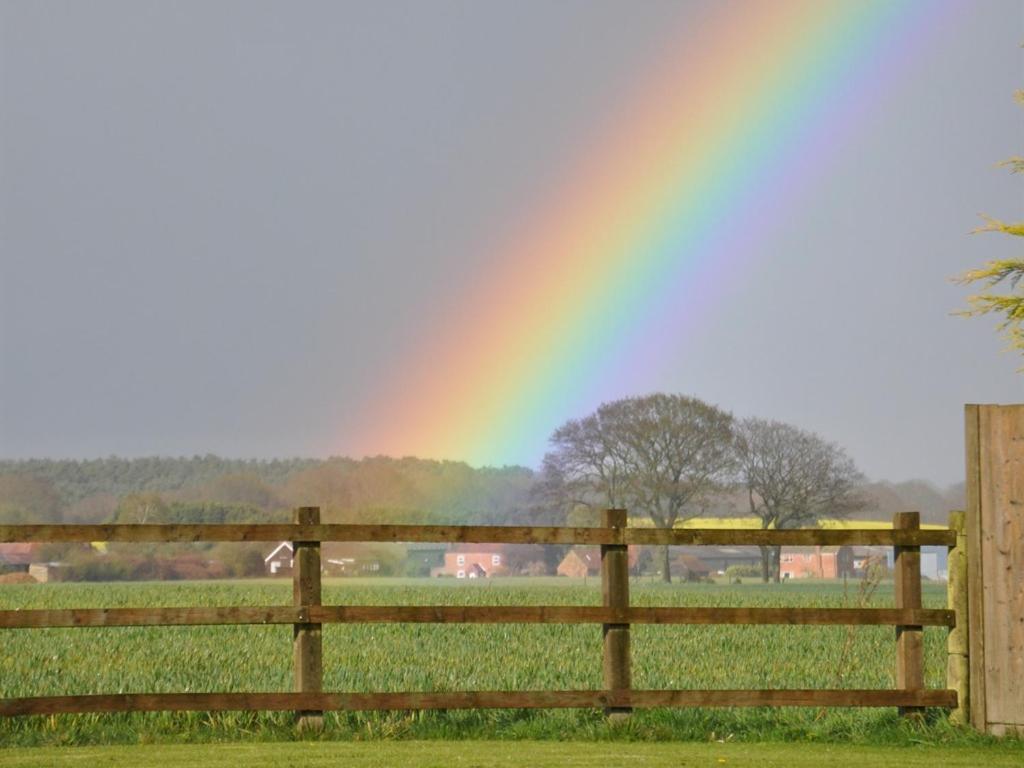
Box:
left=0, top=0, right=1024, bottom=483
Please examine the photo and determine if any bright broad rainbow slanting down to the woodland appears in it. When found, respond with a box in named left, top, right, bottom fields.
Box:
left=350, top=0, right=955, bottom=465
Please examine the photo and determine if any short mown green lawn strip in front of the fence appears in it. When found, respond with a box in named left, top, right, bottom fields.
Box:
left=0, top=741, right=1024, bottom=768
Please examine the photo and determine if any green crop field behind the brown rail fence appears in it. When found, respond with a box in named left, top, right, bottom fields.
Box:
left=0, top=579, right=974, bottom=745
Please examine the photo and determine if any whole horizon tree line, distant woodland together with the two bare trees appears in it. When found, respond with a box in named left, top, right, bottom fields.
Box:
left=0, top=394, right=963, bottom=581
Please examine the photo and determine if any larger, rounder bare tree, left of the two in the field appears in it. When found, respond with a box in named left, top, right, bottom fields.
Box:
left=545, top=394, right=734, bottom=582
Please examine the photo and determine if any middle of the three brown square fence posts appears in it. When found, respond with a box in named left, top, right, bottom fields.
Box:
left=601, top=509, right=633, bottom=721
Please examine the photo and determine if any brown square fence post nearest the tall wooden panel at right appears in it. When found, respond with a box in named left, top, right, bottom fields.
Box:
left=893, top=512, right=925, bottom=715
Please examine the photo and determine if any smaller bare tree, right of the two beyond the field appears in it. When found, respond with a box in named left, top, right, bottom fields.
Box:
left=735, top=419, right=867, bottom=582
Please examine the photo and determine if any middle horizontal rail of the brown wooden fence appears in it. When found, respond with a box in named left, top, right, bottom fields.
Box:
left=0, top=605, right=955, bottom=629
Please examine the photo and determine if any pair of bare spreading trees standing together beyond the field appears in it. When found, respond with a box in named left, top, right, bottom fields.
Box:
left=540, top=394, right=870, bottom=582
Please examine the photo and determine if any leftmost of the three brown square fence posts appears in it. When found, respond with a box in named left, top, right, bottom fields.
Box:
left=292, top=507, right=324, bottom=730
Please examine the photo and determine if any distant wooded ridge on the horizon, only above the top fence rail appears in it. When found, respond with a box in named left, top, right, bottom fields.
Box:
left=0, top=456, right=964, bottom=524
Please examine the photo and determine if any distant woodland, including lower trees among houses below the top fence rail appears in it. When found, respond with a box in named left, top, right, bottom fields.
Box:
left=0, top=456, right=963, bottom=581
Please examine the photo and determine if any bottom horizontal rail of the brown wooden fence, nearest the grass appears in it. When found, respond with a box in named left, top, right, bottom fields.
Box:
left=0, top=689, right=956, bottom=717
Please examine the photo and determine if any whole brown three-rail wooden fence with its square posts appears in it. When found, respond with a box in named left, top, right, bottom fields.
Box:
left=0, top=507, right=966, bottom=726
